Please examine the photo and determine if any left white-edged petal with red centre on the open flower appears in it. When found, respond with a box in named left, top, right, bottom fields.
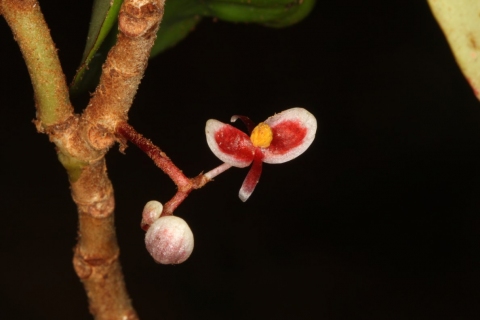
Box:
left=205, top=119, right=255, bottom=168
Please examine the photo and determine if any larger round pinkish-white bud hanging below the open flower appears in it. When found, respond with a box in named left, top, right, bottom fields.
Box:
left=145, top=216, right=193, bottom=264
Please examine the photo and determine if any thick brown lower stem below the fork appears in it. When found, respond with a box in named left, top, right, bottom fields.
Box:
left=71, top=158, right=138, bottom=320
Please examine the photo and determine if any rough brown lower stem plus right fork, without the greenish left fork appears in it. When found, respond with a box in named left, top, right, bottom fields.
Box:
left=72, top=0, right=164, bottom=320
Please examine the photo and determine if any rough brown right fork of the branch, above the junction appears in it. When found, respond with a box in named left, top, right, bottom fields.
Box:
left=84, top=0, right=165, bottom=139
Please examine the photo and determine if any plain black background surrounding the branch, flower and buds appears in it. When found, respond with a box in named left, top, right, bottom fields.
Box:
left=0, top=0, right=480, bottom=320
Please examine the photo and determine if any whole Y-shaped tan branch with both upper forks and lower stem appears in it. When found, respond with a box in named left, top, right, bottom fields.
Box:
left=0, top=0, right=164, bottom=320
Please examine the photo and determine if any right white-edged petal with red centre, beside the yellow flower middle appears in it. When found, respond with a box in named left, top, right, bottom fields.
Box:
left=262, top=108, right=317, bottom=163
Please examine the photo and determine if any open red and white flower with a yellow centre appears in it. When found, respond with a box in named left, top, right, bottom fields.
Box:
left=205, top=108, right=317, bottom=202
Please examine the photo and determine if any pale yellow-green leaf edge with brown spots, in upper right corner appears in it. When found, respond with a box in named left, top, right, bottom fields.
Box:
left=428, top=0, right=480, bottom=100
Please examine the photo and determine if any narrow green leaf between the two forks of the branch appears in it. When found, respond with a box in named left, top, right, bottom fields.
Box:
left=70, top=0, right=123, bottom=94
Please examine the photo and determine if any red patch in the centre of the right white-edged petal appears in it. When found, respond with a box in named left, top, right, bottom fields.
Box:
left=268, top=120, right=307, bottom=155
